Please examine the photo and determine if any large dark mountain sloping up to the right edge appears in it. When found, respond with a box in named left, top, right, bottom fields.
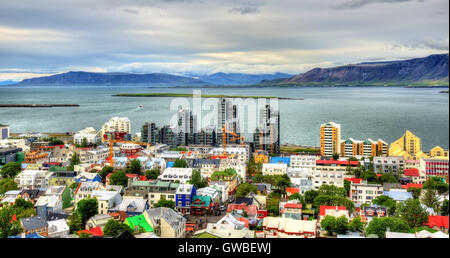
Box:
left=261, top=54, right=449, bottom=86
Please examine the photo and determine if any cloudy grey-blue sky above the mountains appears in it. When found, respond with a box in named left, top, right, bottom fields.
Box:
left=0, top=0, right=449, bottom=81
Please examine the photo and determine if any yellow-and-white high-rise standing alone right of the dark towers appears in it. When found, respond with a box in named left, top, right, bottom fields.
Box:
left=320, top=122, right=341, bottom=156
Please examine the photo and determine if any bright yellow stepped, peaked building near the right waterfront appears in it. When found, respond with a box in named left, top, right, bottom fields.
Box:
left=389, top=130, right=428, bottom=160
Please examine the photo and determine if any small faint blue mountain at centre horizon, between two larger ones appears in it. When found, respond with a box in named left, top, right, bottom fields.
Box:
left=198, top=73, right=292, bottom=85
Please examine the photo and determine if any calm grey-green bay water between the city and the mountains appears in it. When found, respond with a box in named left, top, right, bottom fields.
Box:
left=0, top=86, right=449, bottom=150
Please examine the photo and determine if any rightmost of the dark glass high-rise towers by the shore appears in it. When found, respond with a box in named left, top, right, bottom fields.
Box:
left=253, top=105, right=280, bottom=154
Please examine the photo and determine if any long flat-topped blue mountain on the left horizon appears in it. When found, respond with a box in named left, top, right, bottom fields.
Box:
left=17, top=72, right=206, bottom=85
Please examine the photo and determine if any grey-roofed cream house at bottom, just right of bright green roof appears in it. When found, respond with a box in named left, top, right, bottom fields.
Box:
left=144, top=207, right=186, bottom=238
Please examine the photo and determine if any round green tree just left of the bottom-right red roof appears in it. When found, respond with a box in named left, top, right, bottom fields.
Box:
left=397, top=199, right=428, bottom=228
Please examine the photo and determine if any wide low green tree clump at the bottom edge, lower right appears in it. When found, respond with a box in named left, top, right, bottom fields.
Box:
left=366, top=217, right=410, bottom=238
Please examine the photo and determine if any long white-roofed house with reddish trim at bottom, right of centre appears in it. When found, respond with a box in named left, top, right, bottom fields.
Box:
left=262, top=217, right=317, bottom=238
